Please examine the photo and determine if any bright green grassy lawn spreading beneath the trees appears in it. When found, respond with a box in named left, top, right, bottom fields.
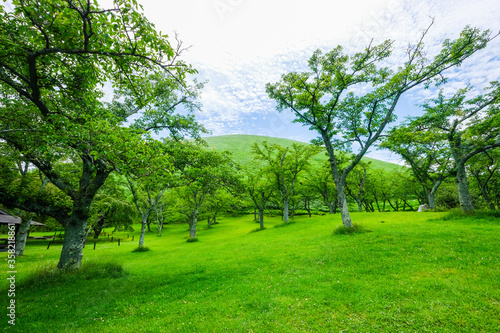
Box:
left=0, top=212, right=500, bottom=333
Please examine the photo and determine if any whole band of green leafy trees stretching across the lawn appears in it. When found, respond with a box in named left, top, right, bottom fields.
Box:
left=0, top=0, right=500, bottom=268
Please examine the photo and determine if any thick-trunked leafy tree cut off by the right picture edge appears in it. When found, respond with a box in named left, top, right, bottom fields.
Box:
left=400, top=81, right=500, bottom=212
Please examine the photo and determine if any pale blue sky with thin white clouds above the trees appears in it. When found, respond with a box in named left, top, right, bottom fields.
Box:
left=47, top=0, right=500, bottom=161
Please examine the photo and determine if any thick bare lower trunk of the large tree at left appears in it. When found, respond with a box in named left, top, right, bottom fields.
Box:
left=57, top=212, right=87, bottom=269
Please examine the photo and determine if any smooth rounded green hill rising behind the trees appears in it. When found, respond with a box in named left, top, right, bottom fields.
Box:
left=204, top=134, right=401, bottom=171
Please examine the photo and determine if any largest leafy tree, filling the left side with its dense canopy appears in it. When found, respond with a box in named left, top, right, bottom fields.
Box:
left=0, top=0, right=203, bottom=268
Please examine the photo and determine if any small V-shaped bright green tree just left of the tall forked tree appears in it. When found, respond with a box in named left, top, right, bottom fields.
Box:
left=251, top=141, right=321, bottom=223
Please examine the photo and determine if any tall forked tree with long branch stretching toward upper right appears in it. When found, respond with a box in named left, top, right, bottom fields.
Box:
left=266, top=24, right=493, bottom=227
